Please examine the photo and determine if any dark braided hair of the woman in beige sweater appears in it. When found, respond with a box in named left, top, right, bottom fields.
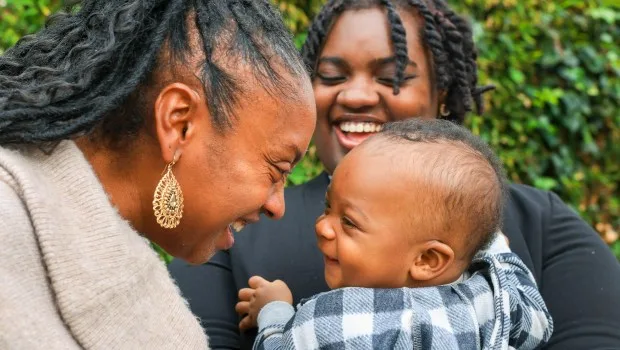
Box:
left=0, top=0, right=305, bottom=145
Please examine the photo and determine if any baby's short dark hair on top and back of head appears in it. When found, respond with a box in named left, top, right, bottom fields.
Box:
left=373, top=118, right=507, bottom=259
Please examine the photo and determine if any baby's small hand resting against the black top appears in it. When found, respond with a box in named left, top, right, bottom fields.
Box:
left=235, top=276, right=293, bottom=330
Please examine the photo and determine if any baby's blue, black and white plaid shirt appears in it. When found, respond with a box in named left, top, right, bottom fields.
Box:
left=254, top=238, right=553, bottom=350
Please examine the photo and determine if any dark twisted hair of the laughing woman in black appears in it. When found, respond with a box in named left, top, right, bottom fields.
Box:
left=302, top=0, right=493, bottom=123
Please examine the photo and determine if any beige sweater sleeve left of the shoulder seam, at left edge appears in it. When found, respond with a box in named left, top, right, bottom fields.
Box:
left=0, top=178, right=75, bottom=349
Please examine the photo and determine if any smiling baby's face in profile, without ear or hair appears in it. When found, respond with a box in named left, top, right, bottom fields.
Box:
left=316, top=144, right=425, bottom=289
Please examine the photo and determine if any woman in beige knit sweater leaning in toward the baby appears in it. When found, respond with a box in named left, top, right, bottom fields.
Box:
left=0, top=0, right=316, bottom=349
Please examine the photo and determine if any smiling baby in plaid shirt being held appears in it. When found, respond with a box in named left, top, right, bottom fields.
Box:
left=237, top=119, right=553, bottom=349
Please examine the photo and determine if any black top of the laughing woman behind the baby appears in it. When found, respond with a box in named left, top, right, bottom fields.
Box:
left=169, top=174, right=620, bottom=350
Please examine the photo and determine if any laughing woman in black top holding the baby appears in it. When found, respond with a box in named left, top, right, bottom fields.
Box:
left=170, top=0, right=620, bottom=349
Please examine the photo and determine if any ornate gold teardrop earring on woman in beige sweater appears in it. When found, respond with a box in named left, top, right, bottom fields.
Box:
left=153, top=154, right=183, bottom=229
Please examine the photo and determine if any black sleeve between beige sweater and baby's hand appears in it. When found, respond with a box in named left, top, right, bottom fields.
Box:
left=168, top=252, right=240, bottom=349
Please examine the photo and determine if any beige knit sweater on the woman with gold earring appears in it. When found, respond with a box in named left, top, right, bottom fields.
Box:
left=0, top=141, right=208, bottom=350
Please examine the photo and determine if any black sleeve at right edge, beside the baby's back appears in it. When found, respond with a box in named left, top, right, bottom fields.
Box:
left=540, top=193, right=620, bottom=350
